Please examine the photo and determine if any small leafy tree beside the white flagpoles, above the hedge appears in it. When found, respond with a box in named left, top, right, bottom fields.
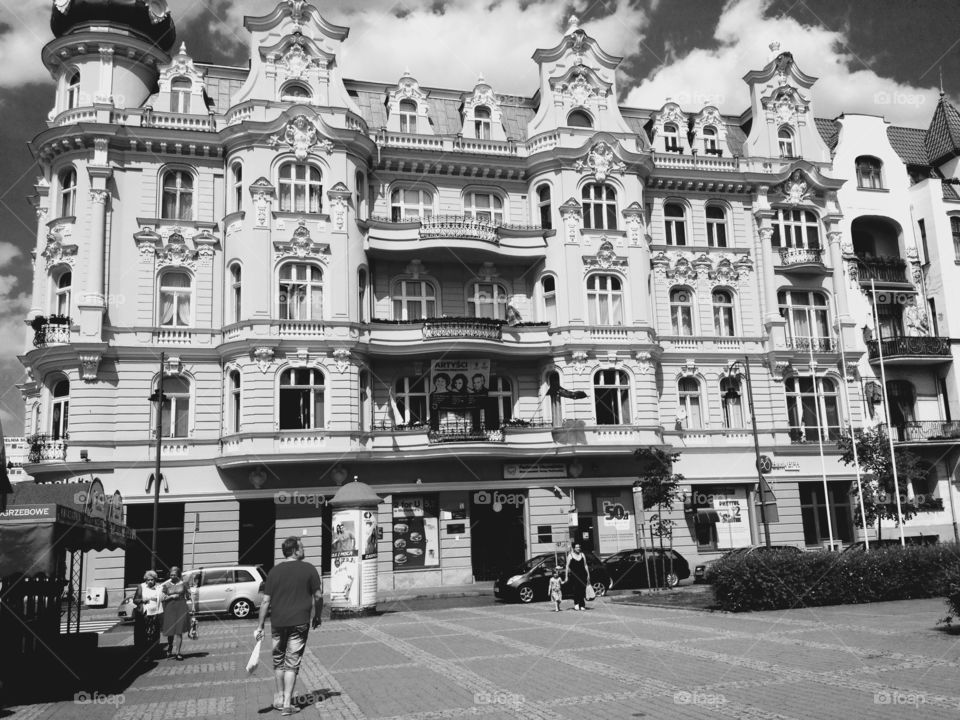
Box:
left=837, top=427, right=927, bottom=539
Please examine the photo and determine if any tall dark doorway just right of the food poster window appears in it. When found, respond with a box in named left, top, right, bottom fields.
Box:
left=470, top=490, right=527, bottom=581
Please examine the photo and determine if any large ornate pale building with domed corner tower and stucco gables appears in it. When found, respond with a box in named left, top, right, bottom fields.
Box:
left=22, top=0, right=952, bottom=600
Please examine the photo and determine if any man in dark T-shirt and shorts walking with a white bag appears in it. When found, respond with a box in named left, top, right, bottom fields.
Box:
left=254, top=537, right=323, bottom=715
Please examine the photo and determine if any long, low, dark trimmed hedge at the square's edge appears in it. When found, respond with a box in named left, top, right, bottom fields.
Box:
left=710, top=543, right=960, bottom=614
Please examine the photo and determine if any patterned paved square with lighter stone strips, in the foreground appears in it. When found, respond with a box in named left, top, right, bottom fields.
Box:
left=0, top=600, right=960, bottom=720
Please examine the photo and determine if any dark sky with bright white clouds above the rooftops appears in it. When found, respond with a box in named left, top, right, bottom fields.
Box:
left=0, top=0, right=960, bottom=435
